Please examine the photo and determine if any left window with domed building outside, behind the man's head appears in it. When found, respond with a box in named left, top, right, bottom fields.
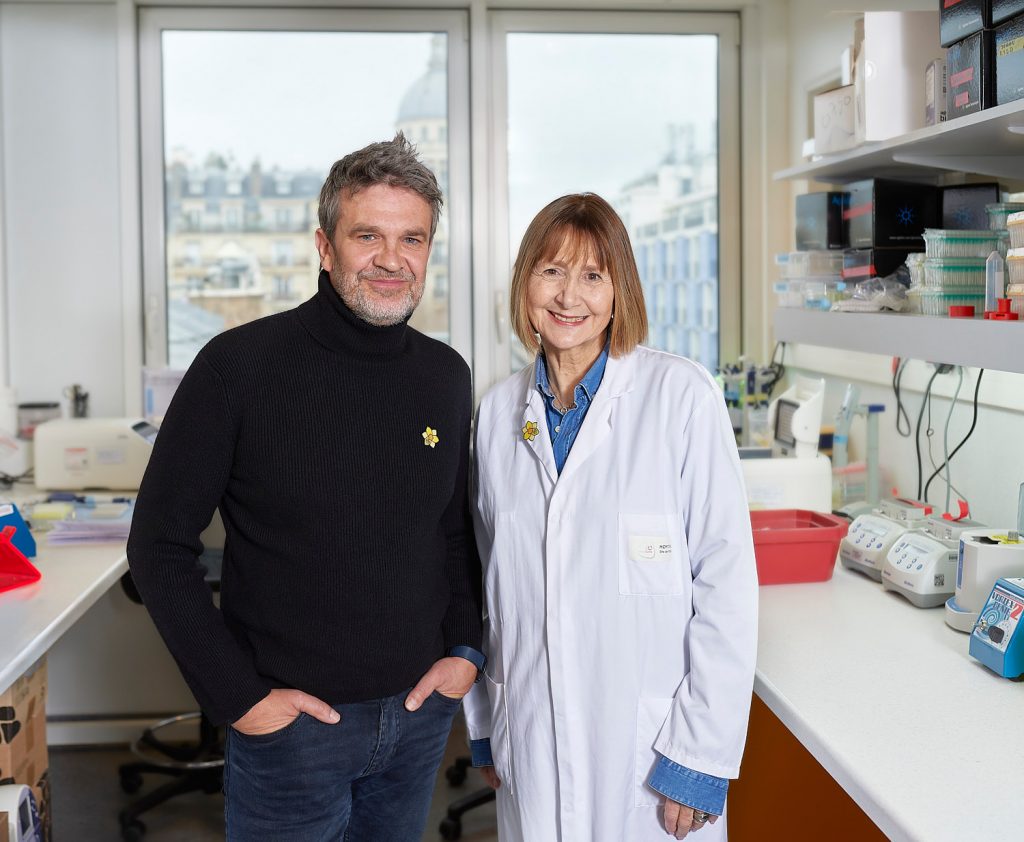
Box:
left=139, top=8, right=471, bottom=367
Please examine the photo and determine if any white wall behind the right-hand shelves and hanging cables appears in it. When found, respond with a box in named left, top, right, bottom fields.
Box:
left=787, top=0, right=1024, bottom=527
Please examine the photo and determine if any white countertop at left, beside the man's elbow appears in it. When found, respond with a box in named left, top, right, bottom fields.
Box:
left=0, top=535, right=128, bottom=692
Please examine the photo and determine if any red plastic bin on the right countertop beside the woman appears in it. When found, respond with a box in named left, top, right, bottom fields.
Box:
left=751, top=509, right=849, bottom=585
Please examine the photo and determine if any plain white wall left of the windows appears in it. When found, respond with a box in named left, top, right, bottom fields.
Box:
left=0, top=3, right=125, bottom=416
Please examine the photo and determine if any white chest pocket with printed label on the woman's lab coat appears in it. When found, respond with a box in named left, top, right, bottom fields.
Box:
left=618, top=512, right=689, bottom=596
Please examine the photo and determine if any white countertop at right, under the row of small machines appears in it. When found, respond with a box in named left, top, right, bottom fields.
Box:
left=754, top=563, right=1024, bottom=842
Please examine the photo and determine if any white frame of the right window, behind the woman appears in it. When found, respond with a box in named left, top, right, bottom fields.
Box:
left=475, top=10, right=743, bottom=394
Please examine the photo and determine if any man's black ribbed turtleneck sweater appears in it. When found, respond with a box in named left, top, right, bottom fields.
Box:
left=128, top=272, right=480, bottom=723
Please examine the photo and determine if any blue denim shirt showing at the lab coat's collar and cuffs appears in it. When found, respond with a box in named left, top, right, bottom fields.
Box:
left=469, top=345, right=729, bottom=815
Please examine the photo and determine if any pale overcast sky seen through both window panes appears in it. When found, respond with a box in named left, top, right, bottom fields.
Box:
left=164, top=32, right=718, bottom=238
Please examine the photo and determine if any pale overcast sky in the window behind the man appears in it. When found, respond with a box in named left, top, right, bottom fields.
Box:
left=164, top=32, right=431, bottom=172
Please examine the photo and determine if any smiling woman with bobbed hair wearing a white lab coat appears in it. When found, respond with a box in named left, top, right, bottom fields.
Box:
left=466, top=194, right=757, bottom=842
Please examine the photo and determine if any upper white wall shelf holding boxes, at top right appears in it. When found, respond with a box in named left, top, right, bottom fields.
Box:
left=774, top=99, right=1024, bottom=184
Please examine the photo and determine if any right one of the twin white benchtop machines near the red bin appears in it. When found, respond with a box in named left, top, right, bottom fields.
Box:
left=882, top=514, right=982, bottom=608
